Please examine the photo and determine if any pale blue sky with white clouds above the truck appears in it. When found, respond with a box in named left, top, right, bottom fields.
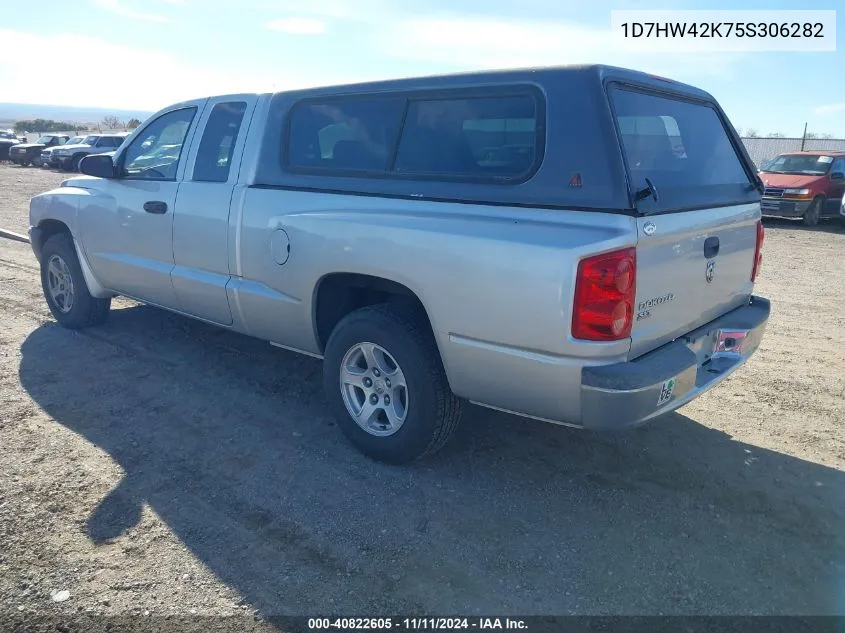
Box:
left=0, top=0, right=845, bottom=138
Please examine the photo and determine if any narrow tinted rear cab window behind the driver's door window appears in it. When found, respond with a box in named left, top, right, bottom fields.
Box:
left=194, top=101, right=246, bottom=182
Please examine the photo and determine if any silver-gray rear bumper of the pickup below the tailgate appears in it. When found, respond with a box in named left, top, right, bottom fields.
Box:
left=581, top=297, right=770, bottom=429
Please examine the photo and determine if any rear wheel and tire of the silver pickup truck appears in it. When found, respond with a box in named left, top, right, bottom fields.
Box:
left=323, top=304, right=463, bottom=464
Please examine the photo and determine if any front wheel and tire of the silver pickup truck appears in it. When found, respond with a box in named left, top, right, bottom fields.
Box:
left=41, top=233, right=111, bottom=330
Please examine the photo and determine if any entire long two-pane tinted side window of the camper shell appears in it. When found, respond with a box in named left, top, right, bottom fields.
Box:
left=284, top=91, right=542, bottom=182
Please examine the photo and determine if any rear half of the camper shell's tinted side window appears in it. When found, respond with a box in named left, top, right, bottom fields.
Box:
left=395, top=95, right=537, bottom=179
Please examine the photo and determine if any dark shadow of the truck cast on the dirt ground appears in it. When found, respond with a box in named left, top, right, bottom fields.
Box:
left=20, top=307, right=845, bottom=615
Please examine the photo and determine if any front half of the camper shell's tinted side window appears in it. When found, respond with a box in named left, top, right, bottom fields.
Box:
left=287, top=98, right=405, bottom=171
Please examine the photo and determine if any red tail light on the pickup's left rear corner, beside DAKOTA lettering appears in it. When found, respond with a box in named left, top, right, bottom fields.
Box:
left=572, top=248, right=637, bottom=341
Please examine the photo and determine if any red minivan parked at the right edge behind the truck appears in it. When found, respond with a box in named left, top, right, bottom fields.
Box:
left=760, top=151, right=845, bottom=226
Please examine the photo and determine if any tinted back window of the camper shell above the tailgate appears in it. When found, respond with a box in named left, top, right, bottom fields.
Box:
left=612, top=88, right=758, bottom=212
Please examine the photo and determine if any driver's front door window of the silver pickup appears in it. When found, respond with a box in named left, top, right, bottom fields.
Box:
left=122, top=108, right=197, bottom=180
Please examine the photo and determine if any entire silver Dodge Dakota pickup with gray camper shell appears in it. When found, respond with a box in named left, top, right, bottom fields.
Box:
left=30, top=66, right=769, bottom=463
